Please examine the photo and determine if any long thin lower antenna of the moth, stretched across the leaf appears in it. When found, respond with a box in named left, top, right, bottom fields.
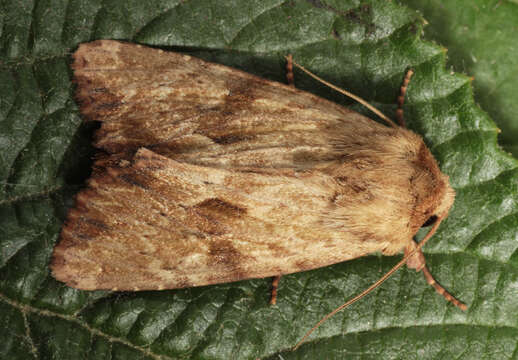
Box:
left=293, top=217, right=443, bottom=351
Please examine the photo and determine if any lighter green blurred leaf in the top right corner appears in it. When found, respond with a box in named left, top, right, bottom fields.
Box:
left=401, top=0, right=518, bottom=157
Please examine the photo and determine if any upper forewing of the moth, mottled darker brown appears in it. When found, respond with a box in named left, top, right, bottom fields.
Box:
left=73, top=40, right=387, bottom=169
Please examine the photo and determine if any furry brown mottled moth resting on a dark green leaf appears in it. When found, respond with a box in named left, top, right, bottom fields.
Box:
left=51, top=40, right=463, bottom=316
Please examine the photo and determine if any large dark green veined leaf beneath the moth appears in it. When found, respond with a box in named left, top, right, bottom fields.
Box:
left=0, top=0, right=518, bottom=359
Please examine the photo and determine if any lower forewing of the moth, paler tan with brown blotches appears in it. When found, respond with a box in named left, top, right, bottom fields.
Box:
left=52, top=149, right=388, bottom=290
